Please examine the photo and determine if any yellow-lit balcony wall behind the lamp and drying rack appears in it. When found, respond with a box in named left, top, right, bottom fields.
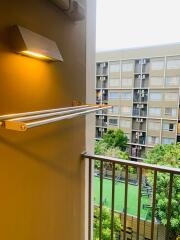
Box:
left=0, top=0, right=86, bottom=240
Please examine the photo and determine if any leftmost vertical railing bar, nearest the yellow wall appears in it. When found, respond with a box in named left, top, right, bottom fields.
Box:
left=88, top=158, right=92, bottom=240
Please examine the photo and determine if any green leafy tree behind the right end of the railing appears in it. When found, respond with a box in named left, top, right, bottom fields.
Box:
left=145, top=143, right=180, bottom=239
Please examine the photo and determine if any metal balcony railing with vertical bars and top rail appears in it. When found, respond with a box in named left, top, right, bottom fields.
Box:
left=83, top=153, right=180, bottom=240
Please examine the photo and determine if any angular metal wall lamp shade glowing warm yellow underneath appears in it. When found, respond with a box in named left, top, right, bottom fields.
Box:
left=11, top=25, right=63, bottom=61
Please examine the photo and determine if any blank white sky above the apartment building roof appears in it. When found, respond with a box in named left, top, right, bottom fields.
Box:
left=96, top=0, right=180, bottom=52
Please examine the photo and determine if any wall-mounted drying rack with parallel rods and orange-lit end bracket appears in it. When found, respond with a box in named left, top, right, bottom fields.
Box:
left=0, top=104, right=112, bottom=132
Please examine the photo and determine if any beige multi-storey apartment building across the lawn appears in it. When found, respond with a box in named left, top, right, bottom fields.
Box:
left=96, top=44, right=180, bottom=161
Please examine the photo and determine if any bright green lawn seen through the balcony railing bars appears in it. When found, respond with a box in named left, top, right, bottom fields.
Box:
left=94, top=177, right=151, bottom=219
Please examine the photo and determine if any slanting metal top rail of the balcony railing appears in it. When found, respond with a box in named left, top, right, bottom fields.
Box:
left=82, top=152, right=180, bottom=175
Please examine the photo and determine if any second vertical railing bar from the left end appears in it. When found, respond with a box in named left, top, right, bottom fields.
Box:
left=99, top=161, right=103, bottom=240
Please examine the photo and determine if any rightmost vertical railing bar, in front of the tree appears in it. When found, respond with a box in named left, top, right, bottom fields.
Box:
left=166, top=173, right=174, bottom=240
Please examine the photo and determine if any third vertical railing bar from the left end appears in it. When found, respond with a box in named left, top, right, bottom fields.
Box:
left=111, top=163, right=115, bottom=240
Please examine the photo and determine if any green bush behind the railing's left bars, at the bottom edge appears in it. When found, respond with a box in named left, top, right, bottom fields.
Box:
left=94, top=206, right=122, bottom=240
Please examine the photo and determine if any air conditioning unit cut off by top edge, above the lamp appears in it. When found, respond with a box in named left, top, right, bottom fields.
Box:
left=50, top=0, right=85, bottom=21
